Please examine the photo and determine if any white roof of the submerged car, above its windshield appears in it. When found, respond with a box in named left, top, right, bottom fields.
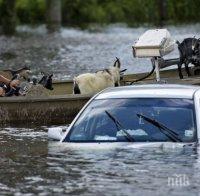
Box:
left=95, top=84, right=200, bottom=99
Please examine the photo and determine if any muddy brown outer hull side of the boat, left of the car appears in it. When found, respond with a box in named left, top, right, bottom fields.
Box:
left=0, top=95, right=91, bottom=126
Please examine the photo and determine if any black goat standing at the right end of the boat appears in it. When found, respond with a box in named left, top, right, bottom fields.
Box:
left=177, top=38, right=200, bottom=79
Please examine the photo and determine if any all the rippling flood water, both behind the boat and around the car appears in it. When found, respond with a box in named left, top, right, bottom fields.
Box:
left=0, top=24, right=200, bottom=196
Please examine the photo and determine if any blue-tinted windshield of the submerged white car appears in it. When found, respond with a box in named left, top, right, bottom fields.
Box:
left=65, top=98, right=196, bottom=142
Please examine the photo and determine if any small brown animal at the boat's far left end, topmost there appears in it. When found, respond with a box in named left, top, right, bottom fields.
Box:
left=3, top=66, right=31, bottom=81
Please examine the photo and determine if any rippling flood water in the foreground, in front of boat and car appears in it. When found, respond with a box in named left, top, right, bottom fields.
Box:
left=0, top=128, right=200, bottom=195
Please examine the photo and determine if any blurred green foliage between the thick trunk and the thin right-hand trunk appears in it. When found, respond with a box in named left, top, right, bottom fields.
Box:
left=63, top=0, right=159, bottom=25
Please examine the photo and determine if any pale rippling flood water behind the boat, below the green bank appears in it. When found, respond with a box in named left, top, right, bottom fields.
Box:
left=0, top=24, right=200, bottom=79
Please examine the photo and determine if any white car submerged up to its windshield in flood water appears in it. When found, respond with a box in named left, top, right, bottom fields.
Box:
left=49, top=84, right=200, bottom=144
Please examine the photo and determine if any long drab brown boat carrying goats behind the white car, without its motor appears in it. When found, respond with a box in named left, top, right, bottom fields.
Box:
left=0, top=66, right=200, bottom=126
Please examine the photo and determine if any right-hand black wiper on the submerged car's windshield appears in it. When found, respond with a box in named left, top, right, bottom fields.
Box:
left=136, top=114, right=182, bottom=142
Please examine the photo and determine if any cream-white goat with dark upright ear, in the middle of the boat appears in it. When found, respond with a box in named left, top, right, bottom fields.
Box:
left=73, top=57, right=126, bottom=94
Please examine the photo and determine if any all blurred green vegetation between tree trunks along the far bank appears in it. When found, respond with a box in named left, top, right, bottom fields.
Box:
left=0, top=0, right=200, bottom=29
